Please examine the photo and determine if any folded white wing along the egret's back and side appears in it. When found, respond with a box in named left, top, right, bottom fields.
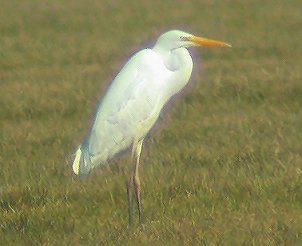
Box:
left=87, top=49, right=169, bottom=165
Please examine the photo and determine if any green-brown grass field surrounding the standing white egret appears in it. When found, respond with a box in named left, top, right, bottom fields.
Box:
left=0, top=0, right=302, bottom=245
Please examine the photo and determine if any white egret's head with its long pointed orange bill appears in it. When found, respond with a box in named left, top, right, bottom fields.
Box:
left=155, top=30, right=231, bottom=50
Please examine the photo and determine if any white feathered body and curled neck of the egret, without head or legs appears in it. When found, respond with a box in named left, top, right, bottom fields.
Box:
left=74, top=34, right=193, bottom=174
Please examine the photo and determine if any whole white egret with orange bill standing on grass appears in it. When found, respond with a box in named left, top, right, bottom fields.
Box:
left=73, top=30, right=231, bottom=224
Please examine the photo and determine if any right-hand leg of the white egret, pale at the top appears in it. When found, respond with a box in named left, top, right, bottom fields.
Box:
left=133, top=140, right=143, bottom=224
